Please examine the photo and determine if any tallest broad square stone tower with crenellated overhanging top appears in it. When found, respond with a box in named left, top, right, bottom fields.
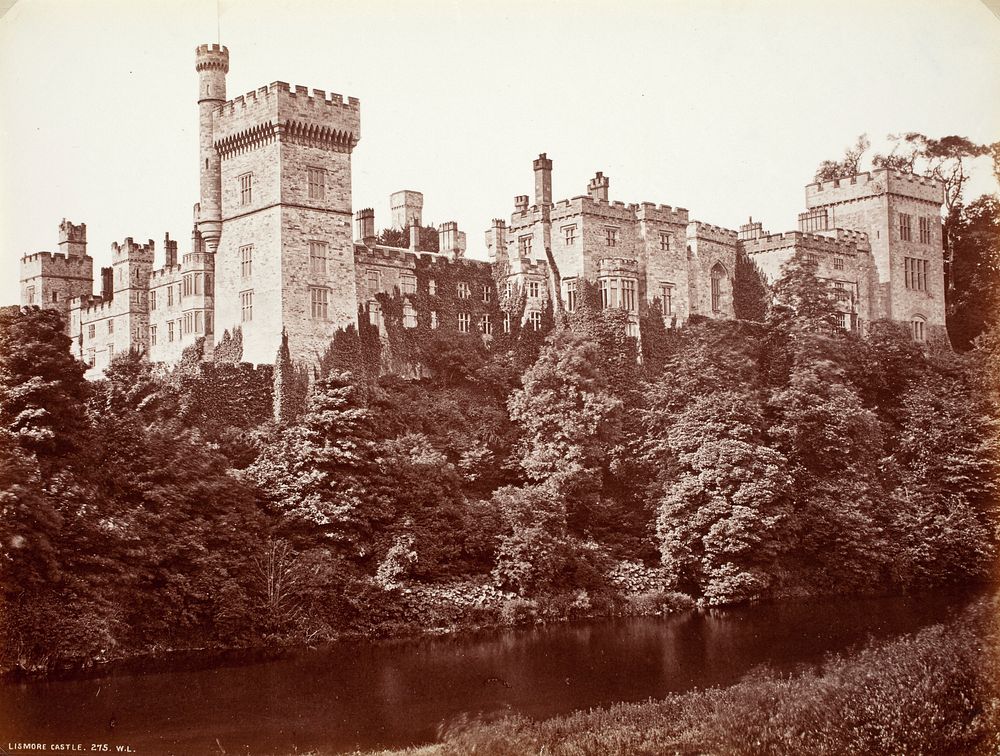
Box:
left=210, top=48, right=361, bottom=363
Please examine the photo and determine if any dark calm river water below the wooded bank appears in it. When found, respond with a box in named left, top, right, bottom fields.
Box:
left=0, top=594, right=969, bottom=756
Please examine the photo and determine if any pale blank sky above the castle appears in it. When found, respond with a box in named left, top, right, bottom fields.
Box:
left=0, top=0, right=1000, bottom=304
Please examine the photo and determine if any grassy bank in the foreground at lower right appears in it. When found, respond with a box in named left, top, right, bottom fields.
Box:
left=360, top=598, right=1000, bottom=756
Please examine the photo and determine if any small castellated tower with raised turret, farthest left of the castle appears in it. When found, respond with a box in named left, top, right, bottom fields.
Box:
left=21, top=218, right=94, bottom=328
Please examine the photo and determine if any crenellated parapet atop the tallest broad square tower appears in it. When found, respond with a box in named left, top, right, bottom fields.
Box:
left=213, top=81, right=361, bottom=153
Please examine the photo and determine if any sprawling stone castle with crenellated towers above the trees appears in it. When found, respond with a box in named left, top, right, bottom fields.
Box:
left=21, top=45, right=945, bottom=376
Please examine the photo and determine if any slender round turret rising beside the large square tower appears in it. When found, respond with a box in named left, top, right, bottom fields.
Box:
left=195, top=45, right=229, bottom=254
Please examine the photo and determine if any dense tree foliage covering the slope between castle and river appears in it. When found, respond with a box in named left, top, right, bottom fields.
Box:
left=0, top=241, right=1000, bottom=669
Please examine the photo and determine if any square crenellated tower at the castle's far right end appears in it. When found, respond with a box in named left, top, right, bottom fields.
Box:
left=799, top=173, right=945, bottom=340
